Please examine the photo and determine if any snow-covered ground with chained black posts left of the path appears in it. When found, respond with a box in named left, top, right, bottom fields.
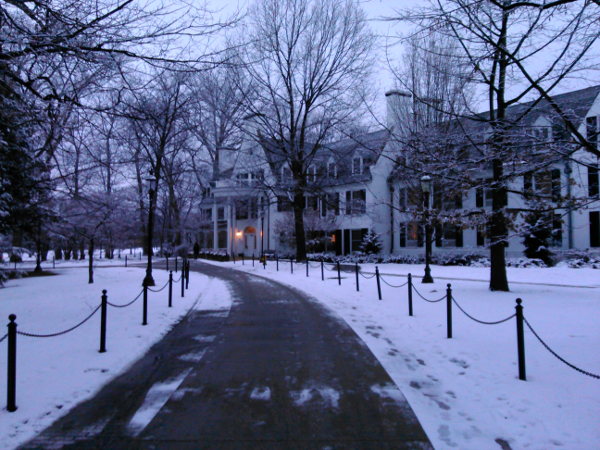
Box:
left=0, top=259, right=231, bottom=450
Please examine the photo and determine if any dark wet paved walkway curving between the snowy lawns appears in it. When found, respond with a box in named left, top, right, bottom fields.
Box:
left=21, top=261, right=432, bottom=450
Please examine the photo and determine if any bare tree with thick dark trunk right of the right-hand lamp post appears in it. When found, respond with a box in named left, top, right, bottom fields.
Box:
left=391, top=0, right=600, bottom=291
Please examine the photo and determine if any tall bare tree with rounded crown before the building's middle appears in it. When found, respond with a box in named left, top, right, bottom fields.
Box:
left=237, top=0, right=375, bottom=260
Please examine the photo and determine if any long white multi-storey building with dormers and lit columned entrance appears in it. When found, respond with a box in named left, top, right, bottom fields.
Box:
left=198, top=86, right=600, bottom=257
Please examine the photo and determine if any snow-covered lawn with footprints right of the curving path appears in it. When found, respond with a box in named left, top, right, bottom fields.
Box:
left=203, top=261, right=600, bottom=450
